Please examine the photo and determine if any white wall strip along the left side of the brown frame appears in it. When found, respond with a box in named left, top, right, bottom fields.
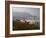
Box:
left=0, top=0, right=5, bottom=38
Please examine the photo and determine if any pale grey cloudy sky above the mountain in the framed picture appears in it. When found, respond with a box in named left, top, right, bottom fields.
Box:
left=12, top=7, right=40, bottom=17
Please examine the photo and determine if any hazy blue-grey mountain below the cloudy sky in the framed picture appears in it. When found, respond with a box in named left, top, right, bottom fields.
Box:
left=13, top=12, right=38, bottom=20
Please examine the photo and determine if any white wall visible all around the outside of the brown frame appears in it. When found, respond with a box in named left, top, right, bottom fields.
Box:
left=0, top=0, right=46, bottom=38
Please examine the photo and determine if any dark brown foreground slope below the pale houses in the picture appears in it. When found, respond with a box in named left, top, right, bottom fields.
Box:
left=13, top=20, right=40, bottom=30
